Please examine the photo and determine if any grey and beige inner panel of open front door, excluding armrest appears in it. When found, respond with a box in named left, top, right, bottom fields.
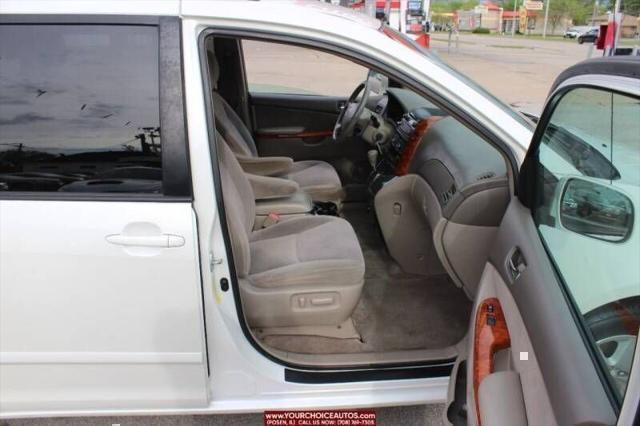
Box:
left=467, top=200, right=616, bottom=424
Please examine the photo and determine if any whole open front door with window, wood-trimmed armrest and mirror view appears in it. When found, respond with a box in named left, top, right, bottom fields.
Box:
left=450, top=59, right=640, bottom=426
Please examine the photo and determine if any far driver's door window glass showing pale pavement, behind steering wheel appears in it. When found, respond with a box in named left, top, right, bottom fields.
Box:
left=242, top=40, right=368, bottom=97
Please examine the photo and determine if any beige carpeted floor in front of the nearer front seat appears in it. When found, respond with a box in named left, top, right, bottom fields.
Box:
left=264, top=203, right=471, bottom=354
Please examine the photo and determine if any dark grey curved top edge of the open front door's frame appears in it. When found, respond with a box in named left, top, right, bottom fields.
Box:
left=550, top=56, right=640, bottom=93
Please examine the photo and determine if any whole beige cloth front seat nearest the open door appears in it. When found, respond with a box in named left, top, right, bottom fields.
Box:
left=217, top=134, right=364, bottom=327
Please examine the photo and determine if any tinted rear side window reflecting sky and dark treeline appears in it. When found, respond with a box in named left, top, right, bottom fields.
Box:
left=0, top=25, right=162, bottom=193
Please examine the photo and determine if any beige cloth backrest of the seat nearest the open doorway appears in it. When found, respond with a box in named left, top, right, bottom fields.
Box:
left=216, top=132, right=256, bottom=278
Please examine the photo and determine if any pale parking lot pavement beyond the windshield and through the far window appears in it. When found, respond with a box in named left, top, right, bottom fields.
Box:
left=244, top=32, right=602, bottom=114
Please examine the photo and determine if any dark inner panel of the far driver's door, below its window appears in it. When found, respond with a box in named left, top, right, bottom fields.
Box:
left=250, top=93, right=360, bottom=161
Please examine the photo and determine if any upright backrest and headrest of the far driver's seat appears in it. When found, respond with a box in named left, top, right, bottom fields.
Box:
left=207, top=50, right=258, bottom=157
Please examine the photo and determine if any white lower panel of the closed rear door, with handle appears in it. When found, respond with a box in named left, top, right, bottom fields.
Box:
left=0, top=200, right=207, bottom=415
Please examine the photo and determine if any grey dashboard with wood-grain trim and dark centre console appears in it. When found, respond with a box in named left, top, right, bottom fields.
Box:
left=362, top=88, right=507, bottom=223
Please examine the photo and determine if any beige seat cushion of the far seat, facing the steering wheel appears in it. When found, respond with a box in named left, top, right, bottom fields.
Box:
left=283, top=160, right=344, bottom=204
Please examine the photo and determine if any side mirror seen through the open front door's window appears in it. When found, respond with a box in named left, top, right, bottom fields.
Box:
left=558, top=178, right=634, bottom=242
